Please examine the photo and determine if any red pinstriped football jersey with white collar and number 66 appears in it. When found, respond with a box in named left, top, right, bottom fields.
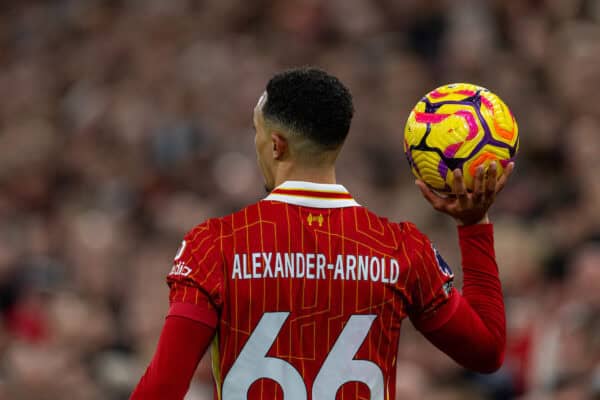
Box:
left=167, top=181, right=453, bottom=400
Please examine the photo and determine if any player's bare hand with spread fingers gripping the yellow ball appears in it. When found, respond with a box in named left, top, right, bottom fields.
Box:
left=415, top=161, right=515, bottom=225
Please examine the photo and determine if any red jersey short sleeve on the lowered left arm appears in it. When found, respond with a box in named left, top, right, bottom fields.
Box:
left=167, top=221, right=223, bottom=327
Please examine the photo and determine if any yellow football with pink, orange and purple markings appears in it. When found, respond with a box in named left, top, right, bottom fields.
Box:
left=404, top=83, right=519, bottom=193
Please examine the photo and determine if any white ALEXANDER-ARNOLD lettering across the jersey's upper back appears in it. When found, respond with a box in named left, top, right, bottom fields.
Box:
left=231, top=252, right=400, bottom=284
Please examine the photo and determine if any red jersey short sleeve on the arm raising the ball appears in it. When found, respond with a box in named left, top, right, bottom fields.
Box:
left=402, top=223, right=455, bottom=330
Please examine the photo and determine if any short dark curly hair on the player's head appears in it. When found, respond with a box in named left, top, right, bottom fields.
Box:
left=262, top=67, right=354, bottom=150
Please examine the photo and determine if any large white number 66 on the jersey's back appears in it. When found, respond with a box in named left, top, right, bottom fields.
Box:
left=222, top=312, right=384, bottom=400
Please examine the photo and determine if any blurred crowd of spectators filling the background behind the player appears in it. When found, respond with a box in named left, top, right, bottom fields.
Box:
left=0, top=0, right=600, bottom=400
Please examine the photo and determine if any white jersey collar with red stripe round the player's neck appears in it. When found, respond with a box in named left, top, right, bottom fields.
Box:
left=264, top=181, right=360, bottom=208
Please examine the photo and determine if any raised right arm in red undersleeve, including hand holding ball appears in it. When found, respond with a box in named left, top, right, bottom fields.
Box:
left=413, top=163, right=514, bottom=373
